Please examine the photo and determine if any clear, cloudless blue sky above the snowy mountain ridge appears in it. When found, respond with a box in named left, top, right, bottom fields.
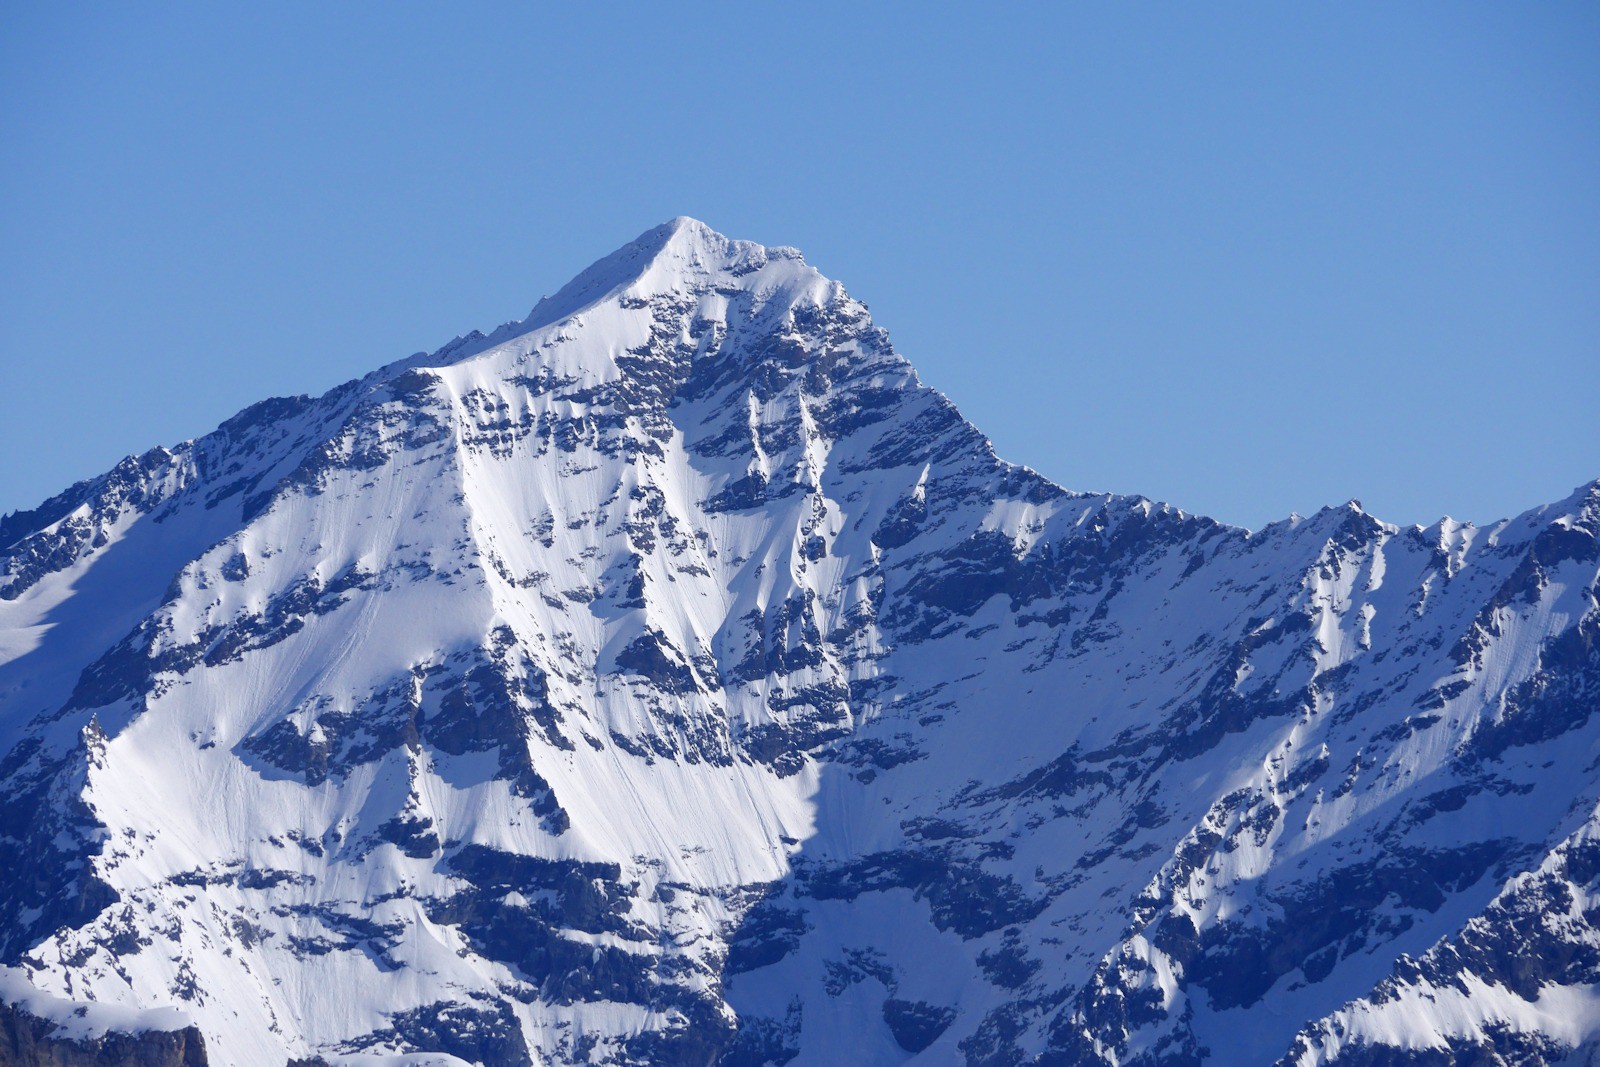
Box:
left=0, top=0, right=1600, bottom=526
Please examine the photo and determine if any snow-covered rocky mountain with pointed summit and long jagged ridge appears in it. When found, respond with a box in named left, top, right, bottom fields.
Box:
left=0, top=219, right=1600, bottom=1067
